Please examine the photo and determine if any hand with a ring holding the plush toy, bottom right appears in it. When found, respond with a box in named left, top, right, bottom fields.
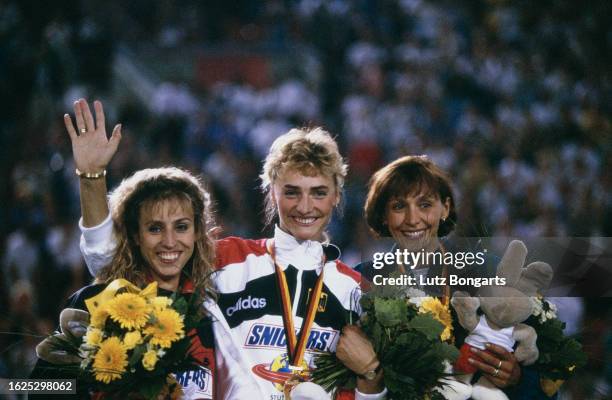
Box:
left=469, top=343, right=521, bottom=389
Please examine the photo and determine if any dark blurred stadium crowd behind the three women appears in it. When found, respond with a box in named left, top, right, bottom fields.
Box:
left=0, top=0, right=612, bottom=398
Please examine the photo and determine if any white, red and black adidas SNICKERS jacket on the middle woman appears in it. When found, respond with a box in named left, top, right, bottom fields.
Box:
left=81, top=218, right=386, bottom=400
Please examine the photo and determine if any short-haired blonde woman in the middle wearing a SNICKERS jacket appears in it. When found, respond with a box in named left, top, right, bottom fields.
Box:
left=74, top=99, right=386, bottom=399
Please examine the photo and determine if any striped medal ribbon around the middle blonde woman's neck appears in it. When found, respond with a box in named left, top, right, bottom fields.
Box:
left=266, top=239, right=325, bottom=367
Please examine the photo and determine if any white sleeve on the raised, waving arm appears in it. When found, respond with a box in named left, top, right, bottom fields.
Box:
left=79, top=214, right=117, bottom=276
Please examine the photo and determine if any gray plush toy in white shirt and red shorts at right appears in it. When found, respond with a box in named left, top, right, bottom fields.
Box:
left=442, top=240, right=553, bottom=400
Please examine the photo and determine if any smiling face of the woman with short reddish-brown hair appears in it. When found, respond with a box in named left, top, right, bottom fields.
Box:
left=384, top=190, right=450, bottom=251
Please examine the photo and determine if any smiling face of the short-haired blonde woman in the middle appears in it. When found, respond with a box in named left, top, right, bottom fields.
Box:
left=272, top=170, right=340, bottom=241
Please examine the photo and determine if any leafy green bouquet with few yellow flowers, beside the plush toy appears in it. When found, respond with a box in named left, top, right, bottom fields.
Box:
left=312, top=286, right=459, bottom=400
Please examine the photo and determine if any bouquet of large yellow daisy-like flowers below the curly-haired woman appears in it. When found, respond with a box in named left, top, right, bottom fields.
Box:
left=37, top=279, right=202, bottom=399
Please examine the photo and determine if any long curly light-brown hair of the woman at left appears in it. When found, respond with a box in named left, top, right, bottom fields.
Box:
left=99, top=167, right=215, bottom=296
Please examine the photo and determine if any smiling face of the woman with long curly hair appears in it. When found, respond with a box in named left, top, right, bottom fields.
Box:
left=136, top=199, right=196, bottom=290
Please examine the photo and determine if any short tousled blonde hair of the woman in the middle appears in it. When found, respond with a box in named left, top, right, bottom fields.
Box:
left=259, top=127, right=348, bottom=224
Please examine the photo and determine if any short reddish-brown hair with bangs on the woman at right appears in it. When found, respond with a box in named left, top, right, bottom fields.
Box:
left=364, top=156, right=457, bottom=237
